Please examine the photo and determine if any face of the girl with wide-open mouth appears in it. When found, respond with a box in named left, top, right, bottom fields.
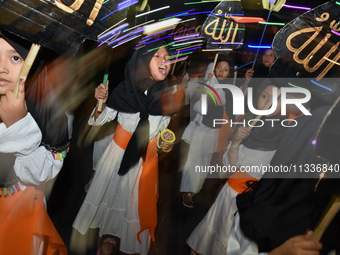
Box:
left=150, top=47, right=171, bottom=81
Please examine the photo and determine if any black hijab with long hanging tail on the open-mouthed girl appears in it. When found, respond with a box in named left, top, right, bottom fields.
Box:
left=107, top=42, right=169, bottom=175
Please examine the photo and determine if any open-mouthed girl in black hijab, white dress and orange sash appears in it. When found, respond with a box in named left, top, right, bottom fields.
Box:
left=73, top=42, right=172, bottom=255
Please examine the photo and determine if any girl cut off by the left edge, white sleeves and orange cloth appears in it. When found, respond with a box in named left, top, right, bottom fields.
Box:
left=0, top=30, right=68, bottom=254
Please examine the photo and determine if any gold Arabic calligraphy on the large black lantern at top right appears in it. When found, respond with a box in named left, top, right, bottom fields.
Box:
left=286, top=12, right=340, bottom=81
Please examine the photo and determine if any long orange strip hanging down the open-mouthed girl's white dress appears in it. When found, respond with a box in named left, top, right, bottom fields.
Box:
left=137, top=136, right=158, bottom=242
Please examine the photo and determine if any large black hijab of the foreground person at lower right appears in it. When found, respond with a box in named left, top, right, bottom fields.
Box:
left=237, top=106, right=329, bottom=252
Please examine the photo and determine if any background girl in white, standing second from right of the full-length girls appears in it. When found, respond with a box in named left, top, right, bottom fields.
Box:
left=180, top=59, right=230, bottom=208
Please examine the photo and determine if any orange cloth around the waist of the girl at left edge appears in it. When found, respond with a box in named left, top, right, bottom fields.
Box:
left=0, top=186, right=67, bottom=255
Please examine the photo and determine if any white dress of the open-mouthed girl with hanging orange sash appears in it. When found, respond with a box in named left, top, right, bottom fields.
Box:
left=73, top=107, right=170, bottom=255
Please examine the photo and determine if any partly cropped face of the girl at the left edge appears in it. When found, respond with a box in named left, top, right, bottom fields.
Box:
left=0, top=37, right=24, bottom=95
